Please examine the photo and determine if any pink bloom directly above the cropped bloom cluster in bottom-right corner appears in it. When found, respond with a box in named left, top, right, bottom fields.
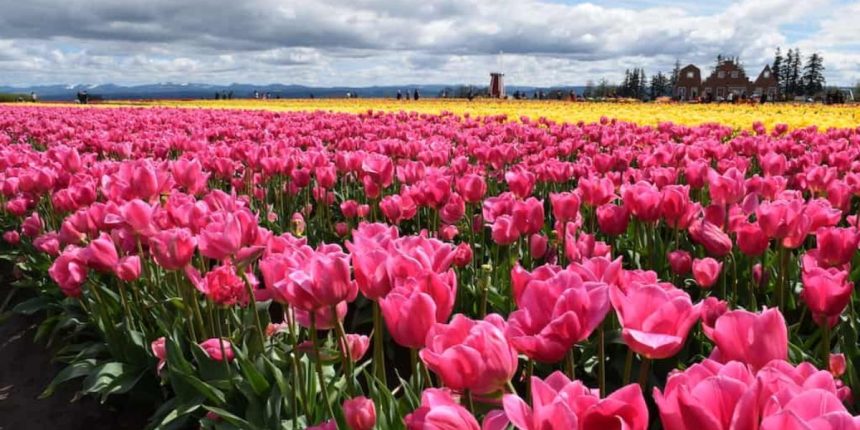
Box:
left=709, top=308, right=788, bottom=370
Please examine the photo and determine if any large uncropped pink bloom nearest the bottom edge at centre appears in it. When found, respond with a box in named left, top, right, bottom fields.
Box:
left=420, top=314, right=517, bottom=394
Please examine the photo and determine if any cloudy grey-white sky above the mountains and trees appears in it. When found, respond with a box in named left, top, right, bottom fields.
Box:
left=0, top=0, right=860, bottom=86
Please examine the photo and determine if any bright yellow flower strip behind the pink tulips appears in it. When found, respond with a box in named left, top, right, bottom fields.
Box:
left=13, top=99, right=860, bottom=129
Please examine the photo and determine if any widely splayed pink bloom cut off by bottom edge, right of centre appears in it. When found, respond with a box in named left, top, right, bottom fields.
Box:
left=500, top=371, right=648, bottom=430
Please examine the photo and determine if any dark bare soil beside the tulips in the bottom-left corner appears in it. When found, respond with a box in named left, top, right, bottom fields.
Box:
left=0, top=298, right=146, bottom=430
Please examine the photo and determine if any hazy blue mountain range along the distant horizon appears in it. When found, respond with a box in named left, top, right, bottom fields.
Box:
left=0, top=82, right=585, bottom=100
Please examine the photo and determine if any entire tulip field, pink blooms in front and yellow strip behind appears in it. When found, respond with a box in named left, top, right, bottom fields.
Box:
left=0, top=101, right=860, bottom=430
